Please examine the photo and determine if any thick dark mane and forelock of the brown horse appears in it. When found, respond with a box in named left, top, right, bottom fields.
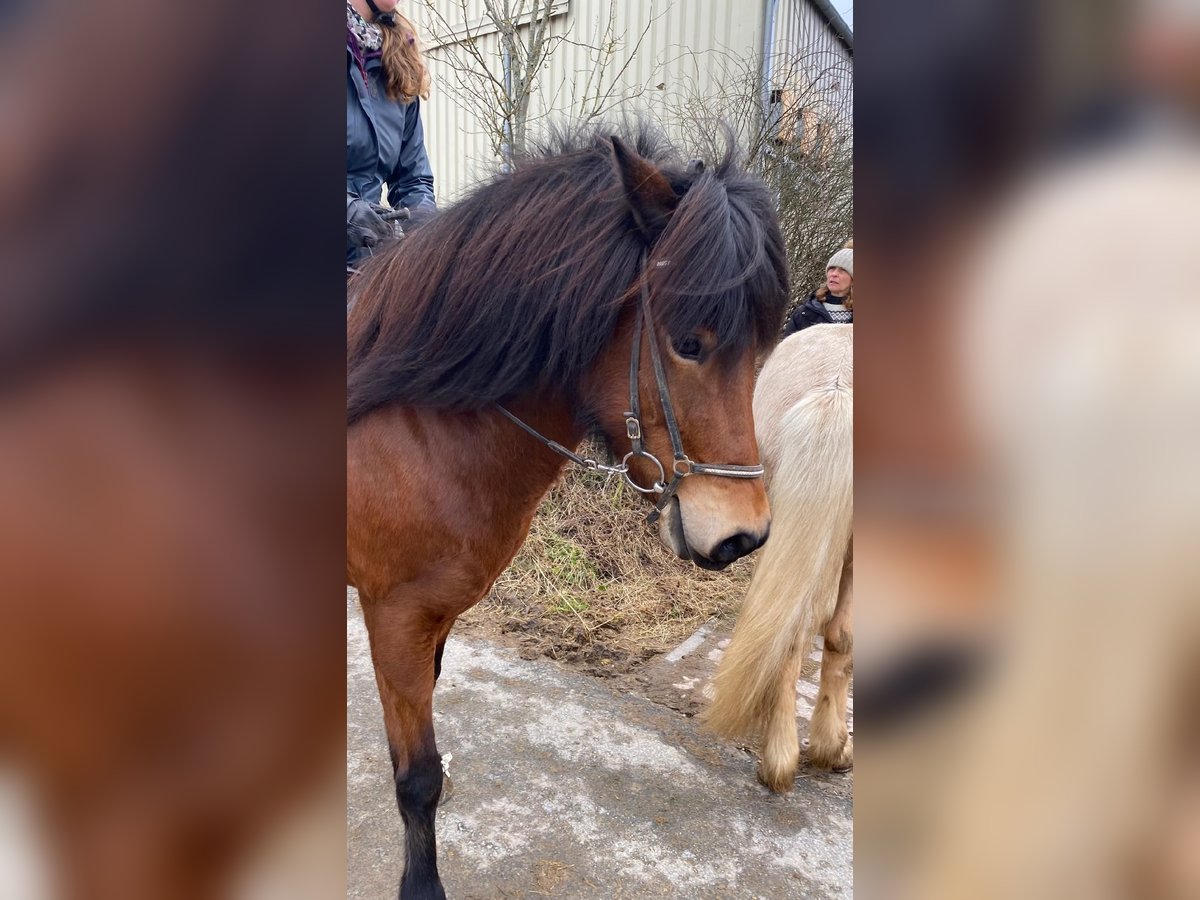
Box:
left=347, top=124, right=787, bottom=422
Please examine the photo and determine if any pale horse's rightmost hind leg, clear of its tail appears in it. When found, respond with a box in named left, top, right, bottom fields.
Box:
left=809, top=558, right=854, bottom=772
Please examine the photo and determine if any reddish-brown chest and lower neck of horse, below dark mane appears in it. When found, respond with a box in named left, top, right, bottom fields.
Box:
left=347, top=397, right=581, bottom=602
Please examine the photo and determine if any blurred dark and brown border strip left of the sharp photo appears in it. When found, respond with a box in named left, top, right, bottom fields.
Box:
left=0, top=0, right=344, bottom=900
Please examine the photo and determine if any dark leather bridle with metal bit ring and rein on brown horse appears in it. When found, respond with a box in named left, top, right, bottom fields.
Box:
left=497, top=253, right=763, bottom=524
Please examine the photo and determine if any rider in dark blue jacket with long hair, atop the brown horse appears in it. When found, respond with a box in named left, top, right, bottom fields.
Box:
left=346, top=0, right=436, bottom=263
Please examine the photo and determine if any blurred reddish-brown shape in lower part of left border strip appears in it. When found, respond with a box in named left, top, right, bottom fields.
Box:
left=0, top=358, right=344, bottom=898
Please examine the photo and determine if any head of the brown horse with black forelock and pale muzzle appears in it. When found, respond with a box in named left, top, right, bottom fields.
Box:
left=593, top=138, right=787, bottom=569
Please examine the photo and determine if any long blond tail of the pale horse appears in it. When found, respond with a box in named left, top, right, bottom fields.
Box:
left=704, top=374, right=853, bottom=738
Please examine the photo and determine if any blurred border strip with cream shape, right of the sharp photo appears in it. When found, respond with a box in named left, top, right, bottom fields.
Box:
left=854, top=2, right=1200, bottom=900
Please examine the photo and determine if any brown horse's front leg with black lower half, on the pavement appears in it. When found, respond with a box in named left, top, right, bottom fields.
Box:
left=362, top=592, right=449, bottom=900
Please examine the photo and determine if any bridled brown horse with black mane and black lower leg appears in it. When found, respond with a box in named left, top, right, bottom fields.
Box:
left=347, top=128, right=787, bottom=898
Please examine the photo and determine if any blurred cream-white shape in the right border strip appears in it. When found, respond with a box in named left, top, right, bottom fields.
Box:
left=914, top=130, right=1200, bottom=898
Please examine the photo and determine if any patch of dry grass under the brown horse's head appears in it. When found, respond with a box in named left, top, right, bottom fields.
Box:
left=462, top=446, right=754, bottom=674
